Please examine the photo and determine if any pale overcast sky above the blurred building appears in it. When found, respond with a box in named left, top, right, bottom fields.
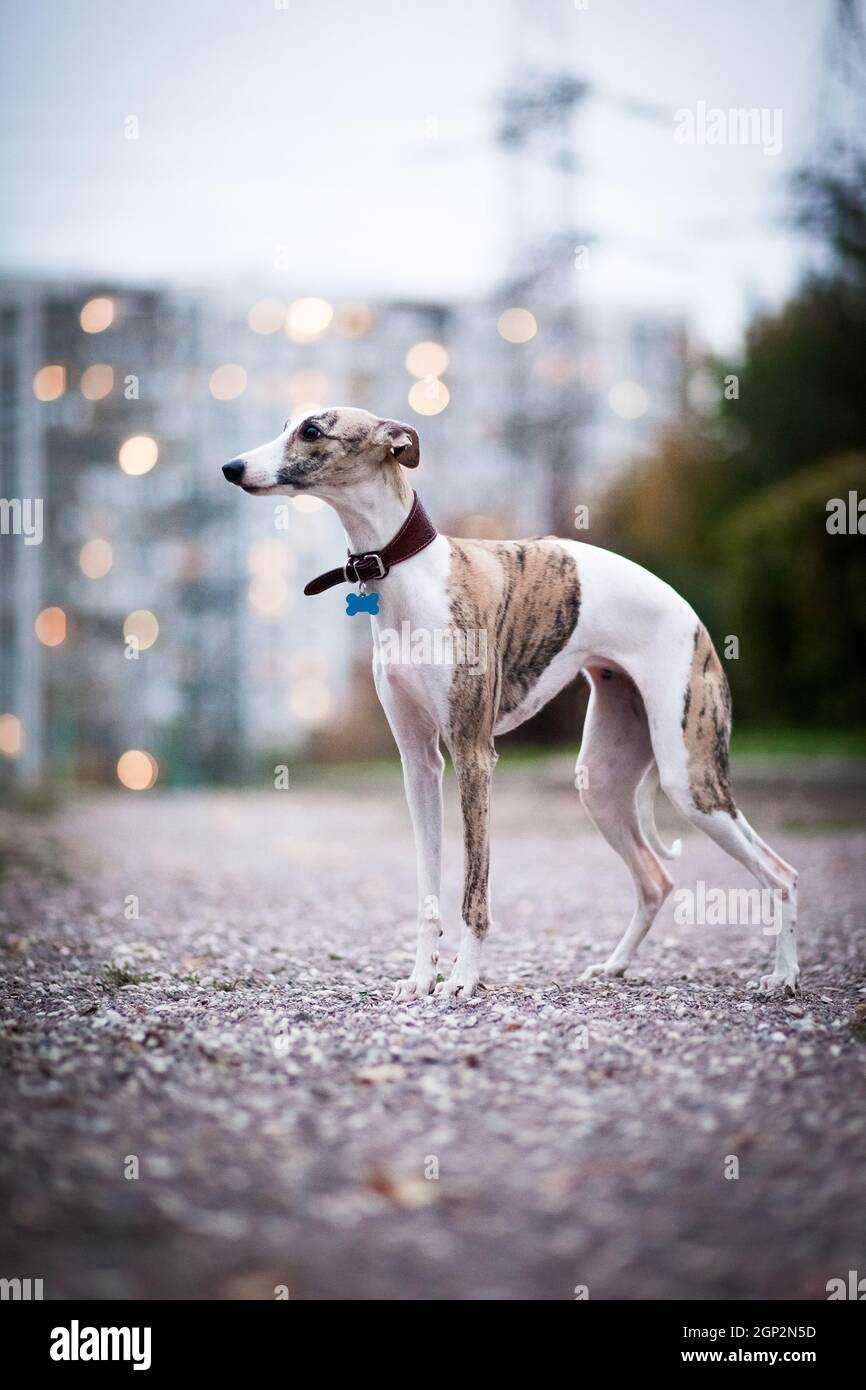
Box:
left=0, top=0, right=828, bottom=346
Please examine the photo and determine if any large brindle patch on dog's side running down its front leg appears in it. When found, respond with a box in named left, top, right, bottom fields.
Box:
left=445, top=538, right=580, bottom=937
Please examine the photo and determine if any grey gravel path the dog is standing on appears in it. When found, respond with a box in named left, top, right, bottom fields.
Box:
left=0, top=762, right=866, bottom=1298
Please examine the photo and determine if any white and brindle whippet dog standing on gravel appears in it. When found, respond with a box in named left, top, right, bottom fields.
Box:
left=222, top=406, right=799, bottom=1001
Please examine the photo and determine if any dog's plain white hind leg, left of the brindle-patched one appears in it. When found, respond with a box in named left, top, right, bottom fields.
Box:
left=577, top=669, right=673, bottom=980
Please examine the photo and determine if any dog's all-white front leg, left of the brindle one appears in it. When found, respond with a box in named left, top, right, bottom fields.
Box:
left=375, top=671, right=445, bottom=1001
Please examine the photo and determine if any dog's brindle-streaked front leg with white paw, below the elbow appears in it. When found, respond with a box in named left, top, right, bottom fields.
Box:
left=436, top=748, right=496, bottom=999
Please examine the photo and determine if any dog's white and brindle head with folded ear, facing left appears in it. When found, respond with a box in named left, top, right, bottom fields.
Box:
left=222, top=406, right=420, bottom=498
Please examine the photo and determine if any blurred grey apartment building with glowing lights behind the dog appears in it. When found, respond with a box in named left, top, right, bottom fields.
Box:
left=0, top=281, right=684, bottom=785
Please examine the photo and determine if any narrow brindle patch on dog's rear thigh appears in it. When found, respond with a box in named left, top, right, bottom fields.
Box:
left=683, top=623, right=737, bottom=816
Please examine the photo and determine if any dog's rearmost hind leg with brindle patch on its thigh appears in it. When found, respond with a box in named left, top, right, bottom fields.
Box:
left=635, top=624, right=799, bottom=991
